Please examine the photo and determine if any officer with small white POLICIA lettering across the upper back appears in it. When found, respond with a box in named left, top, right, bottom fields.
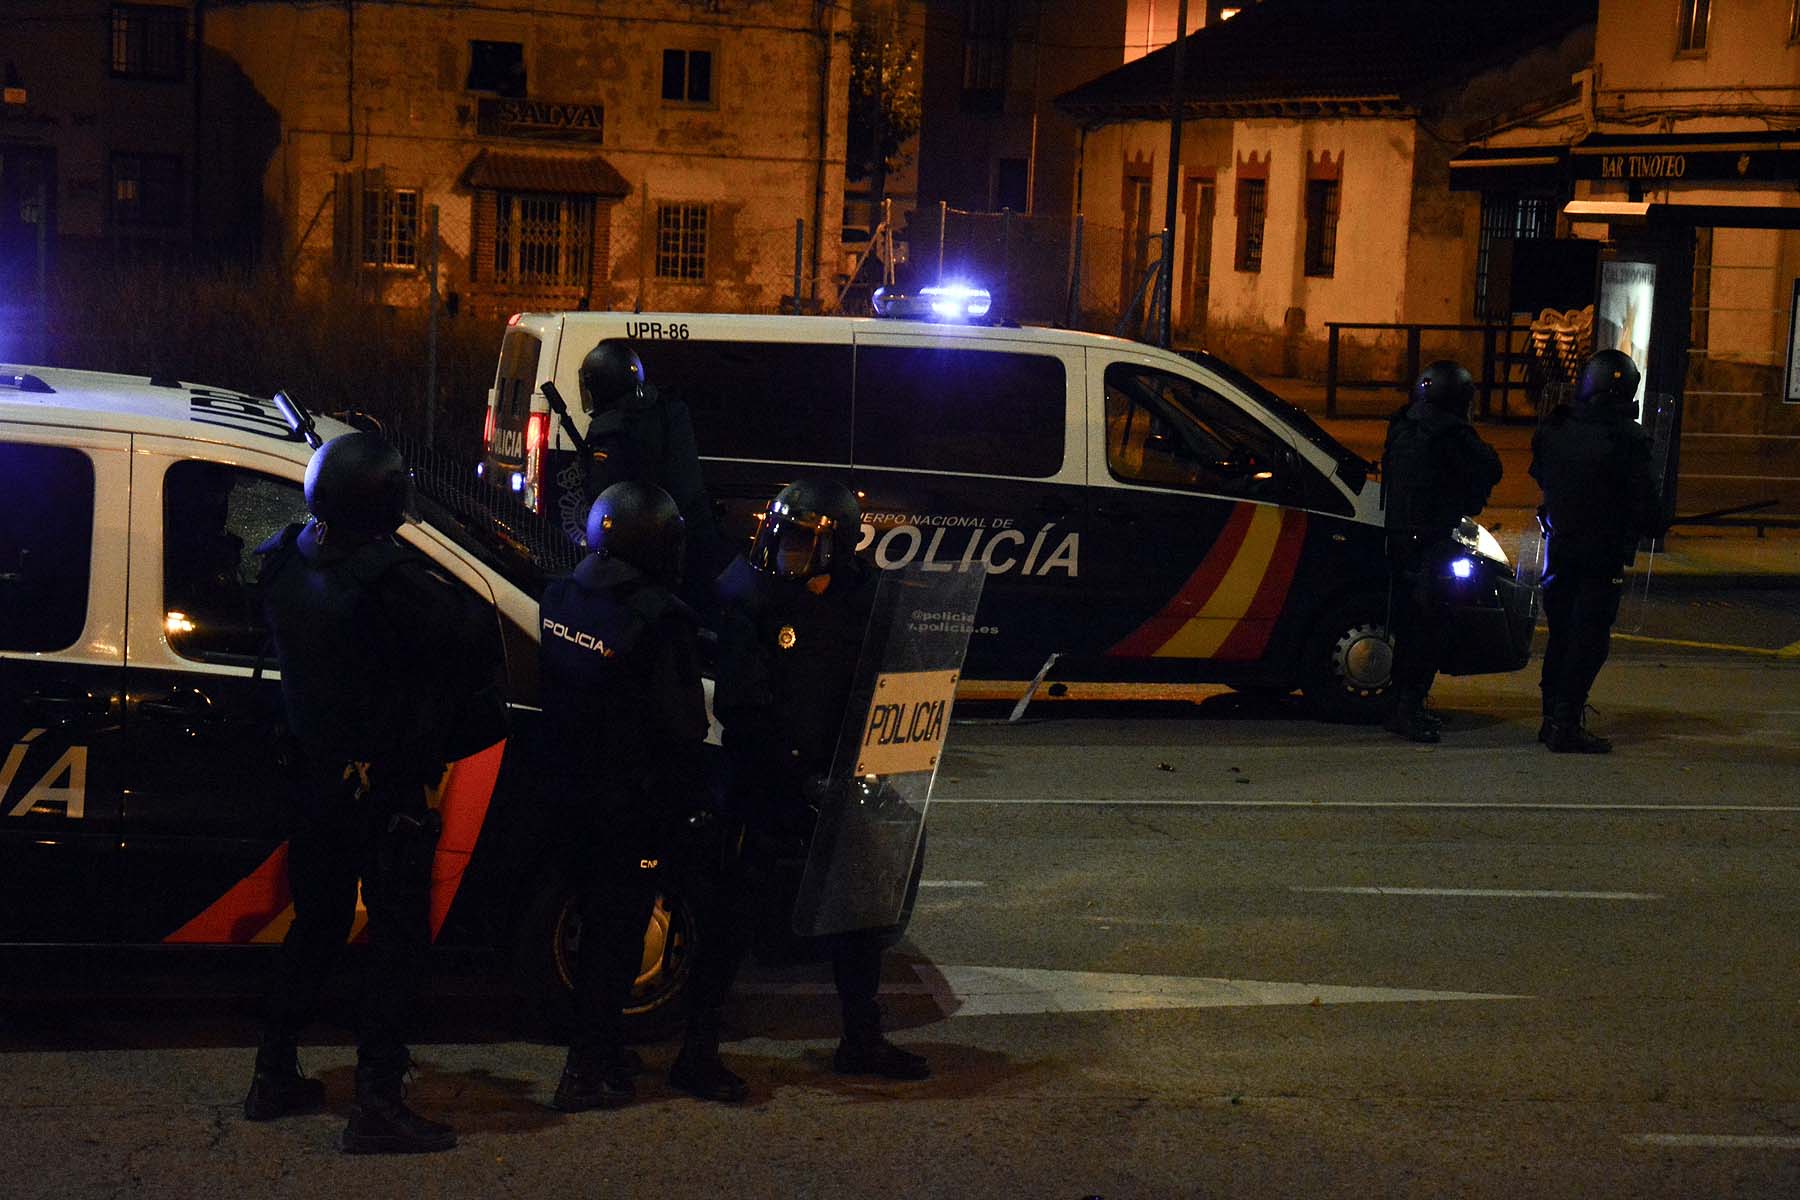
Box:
left=540, top=482, right=745, bottom=1112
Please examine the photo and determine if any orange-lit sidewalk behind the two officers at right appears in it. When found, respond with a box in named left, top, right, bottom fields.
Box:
left=1258, top=376, right=1800, bottom=587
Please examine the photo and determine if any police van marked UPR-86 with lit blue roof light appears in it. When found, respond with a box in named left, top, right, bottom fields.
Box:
left=481, top=288, right=1534, bottom=720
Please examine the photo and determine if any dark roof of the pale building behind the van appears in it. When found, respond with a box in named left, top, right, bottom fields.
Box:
left=1057, top=0, right=1598, bottom=119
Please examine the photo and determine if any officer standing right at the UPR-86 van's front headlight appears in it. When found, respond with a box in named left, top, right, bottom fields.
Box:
left=1381, top=358, right=1501, bottom=743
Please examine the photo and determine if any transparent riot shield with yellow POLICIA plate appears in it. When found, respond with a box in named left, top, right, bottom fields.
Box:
left=794, top=565, right=986, bottom=937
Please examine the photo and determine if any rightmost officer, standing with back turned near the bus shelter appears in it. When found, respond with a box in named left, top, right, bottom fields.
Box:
left=1532, top=351, right=1665, bottom=754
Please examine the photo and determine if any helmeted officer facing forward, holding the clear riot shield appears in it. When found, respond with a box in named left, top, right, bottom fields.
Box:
left=697, top=480, right=931, bottom=1079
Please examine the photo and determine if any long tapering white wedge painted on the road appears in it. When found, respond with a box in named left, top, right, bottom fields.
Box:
left=740, top=964, right=1530, bottom=1016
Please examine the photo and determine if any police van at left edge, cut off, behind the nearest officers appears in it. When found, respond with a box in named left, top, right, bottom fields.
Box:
left=0, top=367, right=892, bottom=1024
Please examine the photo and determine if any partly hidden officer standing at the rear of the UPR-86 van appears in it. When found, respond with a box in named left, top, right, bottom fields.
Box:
left=576, top=338, right=720, bottom=610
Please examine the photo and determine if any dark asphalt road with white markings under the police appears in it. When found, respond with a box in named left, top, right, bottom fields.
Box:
left=0, top=604, right=1800, bottom=1200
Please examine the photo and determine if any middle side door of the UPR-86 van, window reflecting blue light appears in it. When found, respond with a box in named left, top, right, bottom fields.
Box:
left=851, top=326, right=1093, bottom=680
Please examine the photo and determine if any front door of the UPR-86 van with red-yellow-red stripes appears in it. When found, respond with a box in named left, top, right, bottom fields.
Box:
left=1089, top=353, right=1310, bottom=678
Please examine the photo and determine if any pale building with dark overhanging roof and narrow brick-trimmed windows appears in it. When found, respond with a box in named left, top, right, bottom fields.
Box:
left=1057, top=0, right=1595, bottom=376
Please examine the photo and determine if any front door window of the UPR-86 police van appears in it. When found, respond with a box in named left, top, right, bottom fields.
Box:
left=1105, top=362, right=1298, bottom=502
